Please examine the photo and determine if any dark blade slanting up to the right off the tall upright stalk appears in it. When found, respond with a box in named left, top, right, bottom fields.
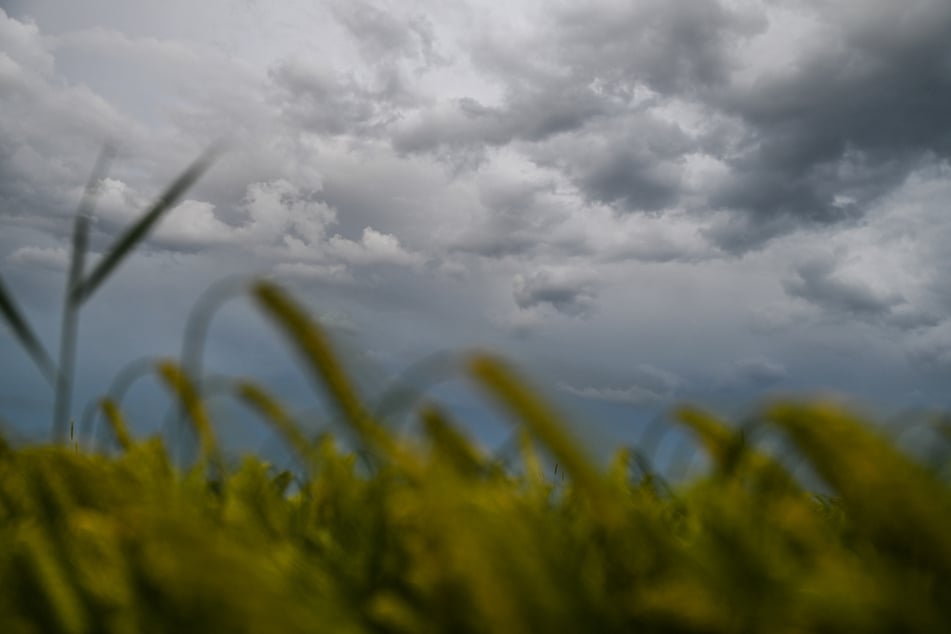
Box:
left=72, top=145, right=220, bottom=304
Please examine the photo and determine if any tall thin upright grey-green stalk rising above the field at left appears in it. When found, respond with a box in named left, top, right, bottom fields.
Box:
left=53, top=144, right=115, bottom=442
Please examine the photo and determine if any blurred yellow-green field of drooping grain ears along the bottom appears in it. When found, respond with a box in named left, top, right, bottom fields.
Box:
left=0, top=282, right=951, bottom=633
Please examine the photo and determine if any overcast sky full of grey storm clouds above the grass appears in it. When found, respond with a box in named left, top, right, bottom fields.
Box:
left=0, top=0, right=951, bottom=462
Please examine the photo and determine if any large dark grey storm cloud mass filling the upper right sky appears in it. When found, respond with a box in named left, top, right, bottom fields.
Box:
left=393, top=0, right=951, bottom=253
